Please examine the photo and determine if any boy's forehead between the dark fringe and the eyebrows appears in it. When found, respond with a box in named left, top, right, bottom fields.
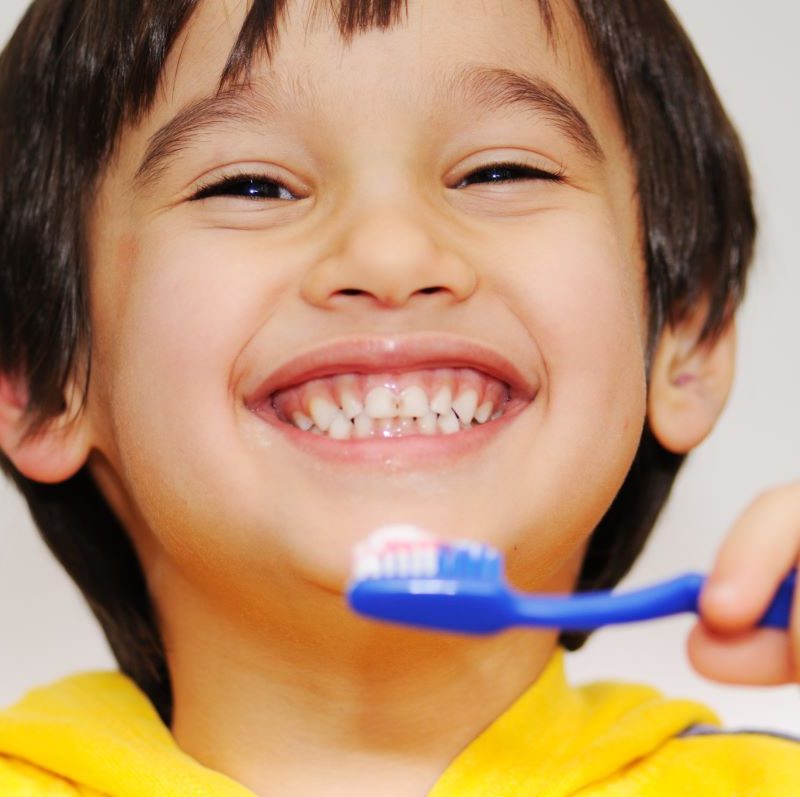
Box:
left=131, top=0, right=615, bottom=155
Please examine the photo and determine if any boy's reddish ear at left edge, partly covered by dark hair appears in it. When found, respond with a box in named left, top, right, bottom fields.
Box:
left=0, top=374, right=90, bottom=484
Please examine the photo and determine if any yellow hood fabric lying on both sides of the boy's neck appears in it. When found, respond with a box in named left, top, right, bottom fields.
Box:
left=0, top=652, right=716, bottom=797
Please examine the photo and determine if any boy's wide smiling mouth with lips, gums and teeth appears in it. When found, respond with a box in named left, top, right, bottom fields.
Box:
left=245, top=332, right=540, bottom=450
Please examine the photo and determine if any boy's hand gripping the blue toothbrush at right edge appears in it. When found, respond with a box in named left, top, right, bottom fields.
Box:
left=688, top=482, right=800, bottom=684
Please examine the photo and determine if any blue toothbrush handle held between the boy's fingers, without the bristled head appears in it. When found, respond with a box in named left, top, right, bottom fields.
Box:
left=510, top=573, right=795, bottom=631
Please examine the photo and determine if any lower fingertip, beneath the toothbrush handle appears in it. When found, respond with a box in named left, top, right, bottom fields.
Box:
left=687, top=623, right=794, bottom=686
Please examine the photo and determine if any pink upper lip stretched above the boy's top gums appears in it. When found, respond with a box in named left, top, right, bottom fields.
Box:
left=246, top=334, right=539, bottom=407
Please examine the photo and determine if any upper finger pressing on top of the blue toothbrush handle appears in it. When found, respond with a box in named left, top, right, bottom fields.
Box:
left=700, top=485, right=800, bottom=633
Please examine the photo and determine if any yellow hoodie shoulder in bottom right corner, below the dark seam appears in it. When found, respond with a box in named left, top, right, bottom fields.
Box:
left=593, top=726, right=800, bottom=797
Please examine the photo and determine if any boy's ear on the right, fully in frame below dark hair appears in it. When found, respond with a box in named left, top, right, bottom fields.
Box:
left=647, top=303, right=736, bottom=454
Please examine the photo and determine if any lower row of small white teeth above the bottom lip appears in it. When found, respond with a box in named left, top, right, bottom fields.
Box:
left=292, top=406, right=502, bottom=440
